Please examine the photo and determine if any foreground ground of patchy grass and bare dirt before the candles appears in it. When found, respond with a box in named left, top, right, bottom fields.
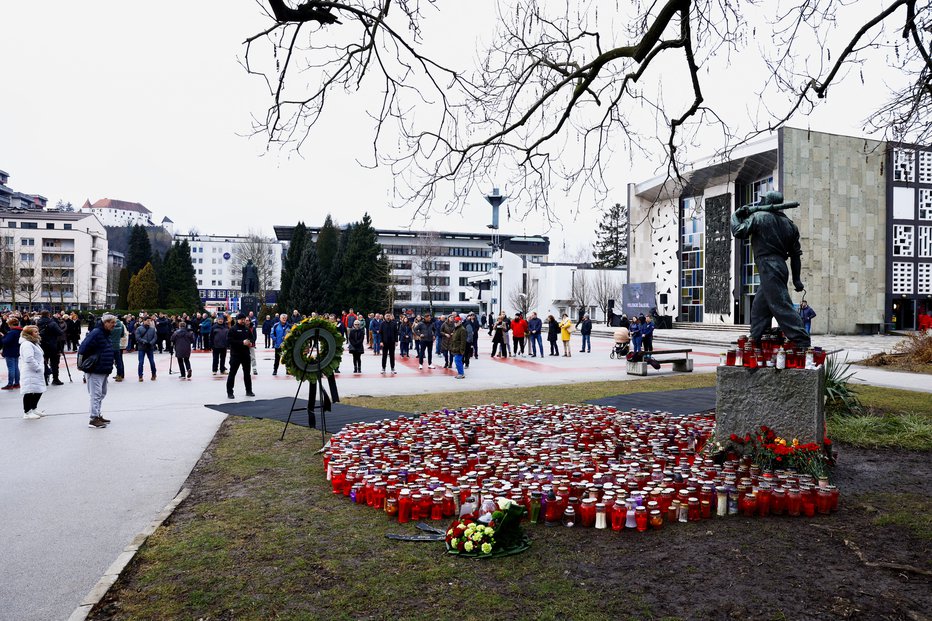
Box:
left=91, top=417, right=932, bottom=620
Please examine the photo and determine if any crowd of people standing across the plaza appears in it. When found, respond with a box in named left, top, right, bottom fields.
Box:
left=0, top=302, right=620, bottom=429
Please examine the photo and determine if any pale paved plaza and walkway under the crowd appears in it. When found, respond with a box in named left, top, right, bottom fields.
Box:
left=0, top=330, right=932, bottom=621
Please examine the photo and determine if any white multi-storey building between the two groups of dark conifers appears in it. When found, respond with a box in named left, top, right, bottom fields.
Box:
left=172, top=234, right=284, bottom=310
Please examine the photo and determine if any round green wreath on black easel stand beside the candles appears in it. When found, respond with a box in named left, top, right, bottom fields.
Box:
left=279, top=327, right=342, bottom=444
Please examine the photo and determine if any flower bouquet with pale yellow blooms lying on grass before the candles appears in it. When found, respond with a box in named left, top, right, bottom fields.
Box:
left=445, top=498, right=531, bottom=558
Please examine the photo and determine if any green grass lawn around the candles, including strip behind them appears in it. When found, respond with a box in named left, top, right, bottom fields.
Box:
left=90, top=374, right=932, bottom=621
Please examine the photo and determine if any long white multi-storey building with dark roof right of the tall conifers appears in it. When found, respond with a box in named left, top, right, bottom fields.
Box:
left=275, top=226, right=550, bottom=313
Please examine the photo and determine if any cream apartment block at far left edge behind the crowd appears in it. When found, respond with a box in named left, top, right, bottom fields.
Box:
left=0, top=209, right=107, bottom=309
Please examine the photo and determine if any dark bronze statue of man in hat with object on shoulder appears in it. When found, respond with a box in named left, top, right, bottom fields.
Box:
left=731, top=192, right=811, bottom=347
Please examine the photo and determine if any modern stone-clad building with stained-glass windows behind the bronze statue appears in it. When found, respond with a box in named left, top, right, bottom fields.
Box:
left=628, top=127, right=932, bottom=333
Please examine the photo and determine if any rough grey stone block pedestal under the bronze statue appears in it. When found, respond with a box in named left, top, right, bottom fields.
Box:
left=715, top=367, right=825, bottom=444
